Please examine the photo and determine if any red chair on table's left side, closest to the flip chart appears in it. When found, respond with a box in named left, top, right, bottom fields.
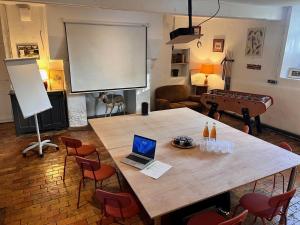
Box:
left=60, top=137, right=100, bottom=181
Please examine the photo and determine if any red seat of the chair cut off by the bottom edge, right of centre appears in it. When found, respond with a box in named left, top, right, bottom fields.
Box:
left=187, top=211, right=225, bottom=225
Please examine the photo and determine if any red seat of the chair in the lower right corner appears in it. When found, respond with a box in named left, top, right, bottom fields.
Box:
left=240, top=193, right=273, bottom=218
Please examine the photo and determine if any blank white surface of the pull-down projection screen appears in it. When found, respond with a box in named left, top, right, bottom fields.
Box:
left=65, top=22, right=147, bottom=93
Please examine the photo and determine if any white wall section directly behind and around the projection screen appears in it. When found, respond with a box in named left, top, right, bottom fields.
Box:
left=46, top=5, right=164, bottom=126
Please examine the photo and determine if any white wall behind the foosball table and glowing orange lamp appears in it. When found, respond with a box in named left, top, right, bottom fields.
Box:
left=161, top=17, right=300, bottom=134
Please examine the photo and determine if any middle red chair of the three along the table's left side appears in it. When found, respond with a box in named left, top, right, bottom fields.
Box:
left=76, top=156, right=121, bottom=208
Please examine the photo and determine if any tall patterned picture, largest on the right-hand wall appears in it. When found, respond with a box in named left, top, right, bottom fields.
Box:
left=245, top=27, right=266, bottom=56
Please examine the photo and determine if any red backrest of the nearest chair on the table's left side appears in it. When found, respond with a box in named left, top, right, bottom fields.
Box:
left=96, top=189, right=131, bottom=209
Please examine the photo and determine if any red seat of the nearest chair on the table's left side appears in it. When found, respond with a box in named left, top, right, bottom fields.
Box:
left=105, top=193, right=140, bottom=218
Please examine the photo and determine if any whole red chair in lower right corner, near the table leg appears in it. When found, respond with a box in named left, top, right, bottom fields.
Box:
left=234, top=189, right=296, bottom=225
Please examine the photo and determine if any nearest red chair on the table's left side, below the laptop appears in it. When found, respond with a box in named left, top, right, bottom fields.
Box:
left=96, top=189, right=140, bottom=225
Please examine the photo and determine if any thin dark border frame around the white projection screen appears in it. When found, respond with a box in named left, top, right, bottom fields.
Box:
left=63, top=20, right=149, bottom=94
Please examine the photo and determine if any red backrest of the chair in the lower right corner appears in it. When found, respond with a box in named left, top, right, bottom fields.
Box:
left=269, top=189, right=296, bottom=218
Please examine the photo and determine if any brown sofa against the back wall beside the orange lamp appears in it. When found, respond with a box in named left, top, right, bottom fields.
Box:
left=155, top=85, right=201, bottom=111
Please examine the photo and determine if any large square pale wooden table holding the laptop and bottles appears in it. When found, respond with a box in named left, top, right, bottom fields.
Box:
left=89, top=108, right=300, bottom=224
